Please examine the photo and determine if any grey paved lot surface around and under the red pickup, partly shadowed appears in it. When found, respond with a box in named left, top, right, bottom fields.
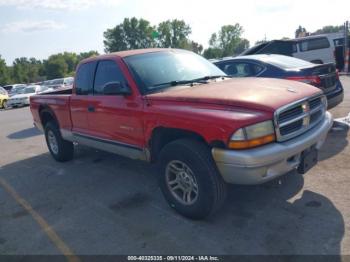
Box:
left=0, top=76, right=350, bottom=255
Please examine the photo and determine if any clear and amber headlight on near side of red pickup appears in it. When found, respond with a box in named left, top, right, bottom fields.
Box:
left=228, top=120, right=276, bottom=149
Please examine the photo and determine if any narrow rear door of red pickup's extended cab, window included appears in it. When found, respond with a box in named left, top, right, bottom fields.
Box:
left=70, top=61, right=96, bottom=134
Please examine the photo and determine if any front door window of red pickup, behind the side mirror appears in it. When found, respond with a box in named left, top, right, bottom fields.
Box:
left=94, top=60, right=125, bottom=95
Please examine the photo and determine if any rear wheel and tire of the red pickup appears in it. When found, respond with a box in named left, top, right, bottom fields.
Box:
left=45, top=122, right=74, bottom=162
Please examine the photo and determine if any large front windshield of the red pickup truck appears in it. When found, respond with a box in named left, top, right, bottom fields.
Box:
left=125, top=50, right=226, bottom=93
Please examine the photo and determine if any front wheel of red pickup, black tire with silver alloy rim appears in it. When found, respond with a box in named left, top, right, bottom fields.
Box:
left=158, top=139, right=227, bottom=219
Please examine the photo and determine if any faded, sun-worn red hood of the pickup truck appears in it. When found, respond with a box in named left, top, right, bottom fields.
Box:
left=146, top=77, right=321, bottom=112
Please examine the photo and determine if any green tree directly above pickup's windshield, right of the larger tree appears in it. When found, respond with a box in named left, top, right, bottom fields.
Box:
left=157, top=19, right=192, bottom=49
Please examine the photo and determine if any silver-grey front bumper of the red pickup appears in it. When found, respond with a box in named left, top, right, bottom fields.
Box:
left=212, top=112, right=333, bottom=185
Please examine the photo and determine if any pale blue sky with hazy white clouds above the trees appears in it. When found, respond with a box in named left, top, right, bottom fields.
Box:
left=0, top=0, right=350, bottom=64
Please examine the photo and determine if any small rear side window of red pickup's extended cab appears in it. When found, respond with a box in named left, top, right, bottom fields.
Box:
left=75, top=62, right=96, bottom=95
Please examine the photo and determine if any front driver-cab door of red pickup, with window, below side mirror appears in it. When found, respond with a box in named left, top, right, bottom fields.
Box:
left=88, top=60, right=143, bottom=149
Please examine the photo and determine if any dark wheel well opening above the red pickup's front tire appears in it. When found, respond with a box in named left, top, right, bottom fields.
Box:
left=149, top=127, right=217, bottom=162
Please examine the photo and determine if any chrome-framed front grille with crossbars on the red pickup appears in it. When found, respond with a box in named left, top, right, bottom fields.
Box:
left=275, top=95, right=326, bottom=141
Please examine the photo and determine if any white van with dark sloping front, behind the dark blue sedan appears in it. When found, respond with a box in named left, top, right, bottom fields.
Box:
left=240, top=33, right=344, bottom=67
